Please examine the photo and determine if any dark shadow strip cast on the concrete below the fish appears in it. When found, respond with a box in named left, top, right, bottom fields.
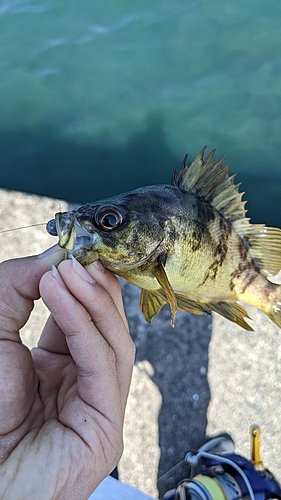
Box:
left=122, top=280, right=212, bottom=497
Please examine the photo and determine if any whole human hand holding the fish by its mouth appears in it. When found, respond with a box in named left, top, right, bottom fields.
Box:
left=0, top=251, right=134, bottom=500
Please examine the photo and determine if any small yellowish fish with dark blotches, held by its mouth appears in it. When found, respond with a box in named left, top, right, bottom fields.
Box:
left=46, top=147, right=281, bottom=330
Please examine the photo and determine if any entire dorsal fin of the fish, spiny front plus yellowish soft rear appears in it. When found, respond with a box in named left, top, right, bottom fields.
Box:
left=172, top=148, right=281, bottom=278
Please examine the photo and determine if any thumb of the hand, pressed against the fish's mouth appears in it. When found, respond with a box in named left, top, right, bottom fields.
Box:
left=0, top=245, right=65, bottom=340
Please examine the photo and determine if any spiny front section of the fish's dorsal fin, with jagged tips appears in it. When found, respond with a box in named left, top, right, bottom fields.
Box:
left=172, top=147, right=249, bottom=226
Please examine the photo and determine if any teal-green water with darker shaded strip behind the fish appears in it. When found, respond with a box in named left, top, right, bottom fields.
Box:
left=0, top=0, right=281, bottom=227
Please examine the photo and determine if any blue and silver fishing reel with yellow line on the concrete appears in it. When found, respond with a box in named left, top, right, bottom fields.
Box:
left=163, top=426, right=281, bottom=500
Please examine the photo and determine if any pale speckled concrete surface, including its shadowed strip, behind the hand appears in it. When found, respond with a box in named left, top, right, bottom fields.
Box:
left=0, top=190, right=281, bottom=498
